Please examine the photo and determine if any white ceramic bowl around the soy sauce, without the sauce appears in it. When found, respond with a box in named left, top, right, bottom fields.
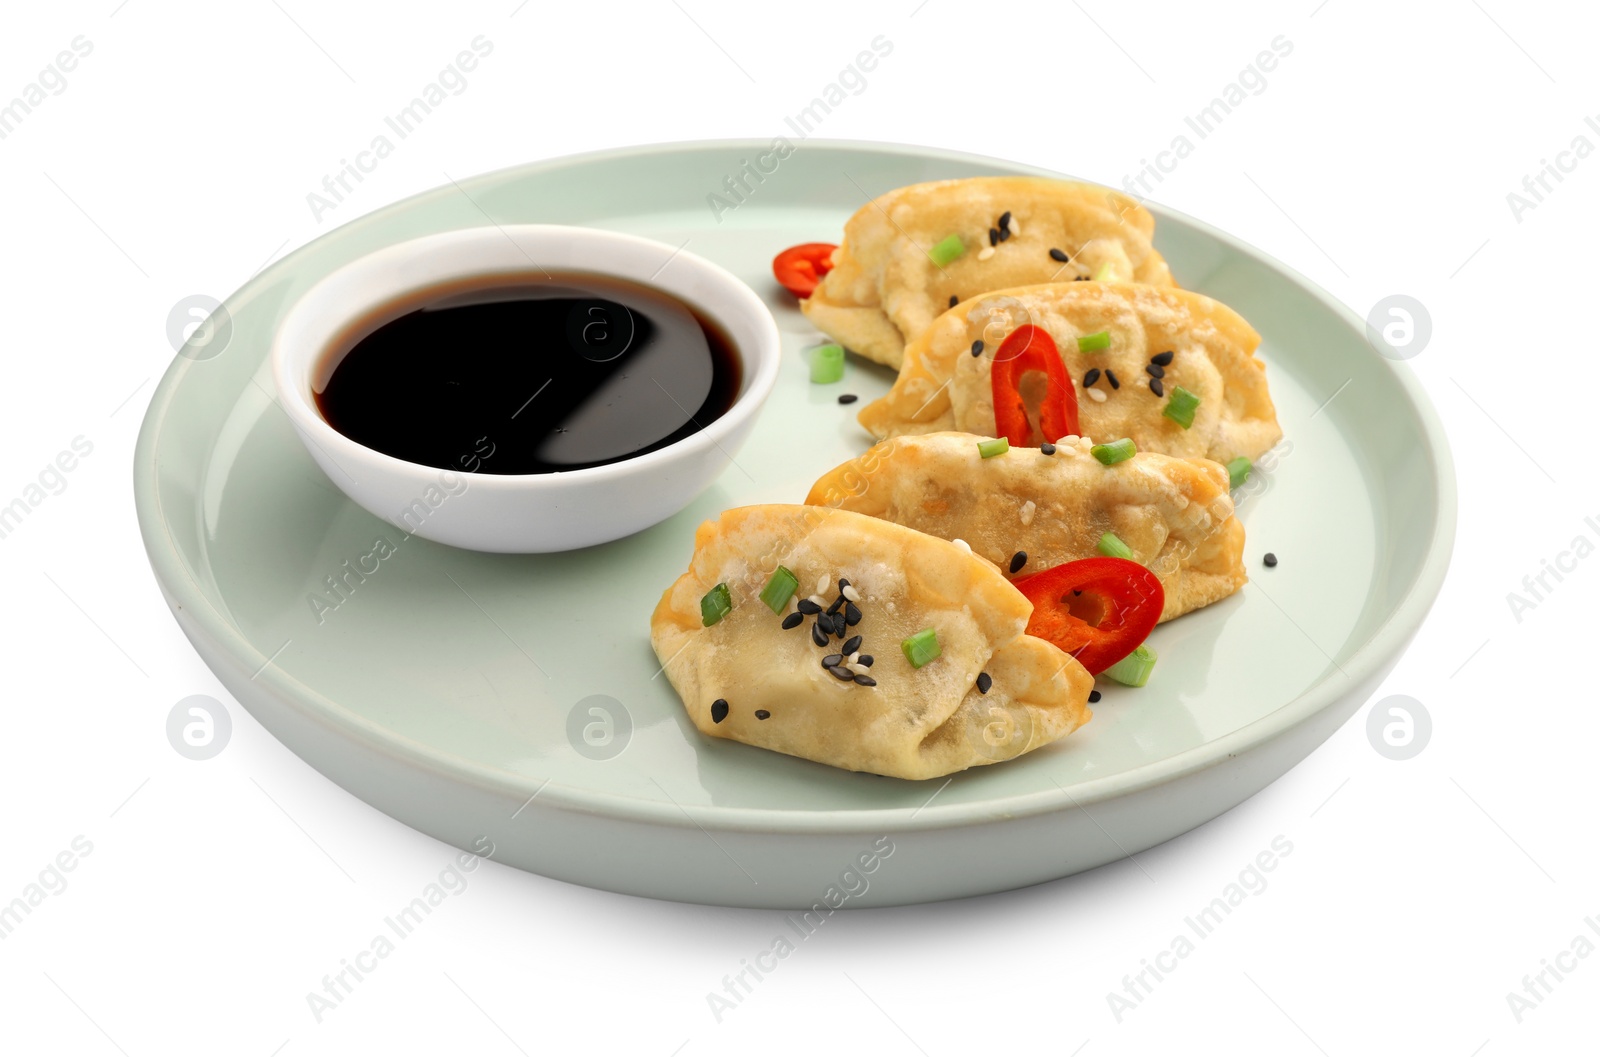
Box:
left=272, top=224, right=779, bottom=553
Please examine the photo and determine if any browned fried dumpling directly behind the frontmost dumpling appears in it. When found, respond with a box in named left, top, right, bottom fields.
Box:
left=806, top=433, right=1246, bottom=620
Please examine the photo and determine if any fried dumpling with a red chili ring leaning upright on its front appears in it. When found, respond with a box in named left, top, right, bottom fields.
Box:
left=858, top=283, right=1283, bottom=462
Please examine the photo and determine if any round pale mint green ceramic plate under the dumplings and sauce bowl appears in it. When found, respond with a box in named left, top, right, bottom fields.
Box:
left=134, top=141, right=1456, bottom=907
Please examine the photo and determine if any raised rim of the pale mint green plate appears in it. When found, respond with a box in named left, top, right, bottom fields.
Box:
left=133, top=138, right=1458, bottom=835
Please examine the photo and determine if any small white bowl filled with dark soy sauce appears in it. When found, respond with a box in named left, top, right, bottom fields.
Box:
left=272, top=224, right=779, bottom=553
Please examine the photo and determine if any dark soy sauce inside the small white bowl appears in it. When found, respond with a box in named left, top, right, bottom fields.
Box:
left=317, top=272, right=741, bottom=473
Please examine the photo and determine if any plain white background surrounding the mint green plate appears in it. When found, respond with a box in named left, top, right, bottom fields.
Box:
left=0, top=0, right=1600, bottom=1057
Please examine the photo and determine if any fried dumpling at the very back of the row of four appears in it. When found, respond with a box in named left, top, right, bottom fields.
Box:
left=800, top=176, right=1173, bottom=368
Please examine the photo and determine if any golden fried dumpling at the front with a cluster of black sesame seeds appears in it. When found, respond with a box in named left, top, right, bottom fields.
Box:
left=650, top=505, right=1093, bottom=779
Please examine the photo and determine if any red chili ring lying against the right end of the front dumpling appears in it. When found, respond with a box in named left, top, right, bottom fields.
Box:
left=1011, top=558, right=1166, bottom=675
